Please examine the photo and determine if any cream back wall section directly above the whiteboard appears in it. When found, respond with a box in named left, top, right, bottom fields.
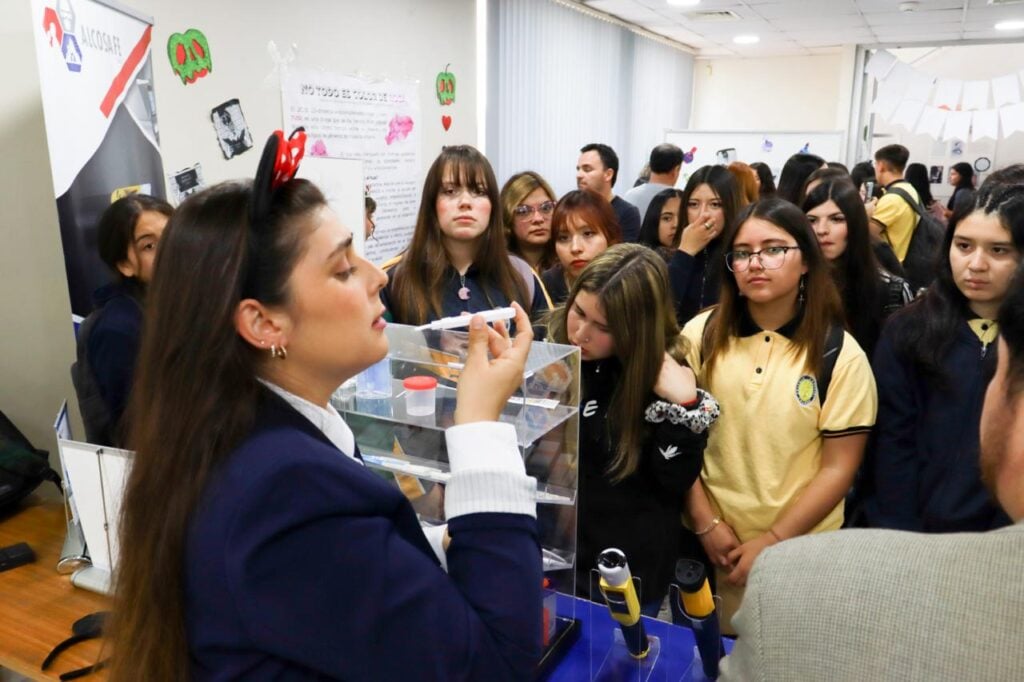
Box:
left=690, top=47, right=855, bottom=138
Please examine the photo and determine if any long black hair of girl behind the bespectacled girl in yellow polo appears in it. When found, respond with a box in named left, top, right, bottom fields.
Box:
left=802, top=178, right=886, bottom=357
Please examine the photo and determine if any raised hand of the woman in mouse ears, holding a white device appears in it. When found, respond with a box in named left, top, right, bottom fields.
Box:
left=455, top=303, right=534, bottom=424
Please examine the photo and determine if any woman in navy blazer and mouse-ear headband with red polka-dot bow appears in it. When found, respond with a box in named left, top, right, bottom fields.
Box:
left=108, top=131, right=543, bottom=682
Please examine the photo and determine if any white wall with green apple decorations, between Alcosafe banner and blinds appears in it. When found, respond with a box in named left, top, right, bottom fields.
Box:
left=128, top=0, right=476, bottom=188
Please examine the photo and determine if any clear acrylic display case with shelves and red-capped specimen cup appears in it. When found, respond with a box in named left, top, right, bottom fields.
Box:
left=332, top=325, right=580, bottom=641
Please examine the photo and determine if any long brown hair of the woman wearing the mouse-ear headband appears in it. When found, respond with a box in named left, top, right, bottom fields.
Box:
left=110, top=180, right=326, bottom=682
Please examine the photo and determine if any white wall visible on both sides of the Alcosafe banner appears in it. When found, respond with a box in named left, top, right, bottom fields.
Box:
left=0, top=0, right=477, bottom=461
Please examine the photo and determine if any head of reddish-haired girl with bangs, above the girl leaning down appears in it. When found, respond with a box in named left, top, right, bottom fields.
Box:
left=542, top=189, right=623, bottom=305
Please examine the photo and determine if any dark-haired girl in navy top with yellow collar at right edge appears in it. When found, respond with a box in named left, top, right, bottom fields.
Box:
left=865, top=184, right=1024, bottom=532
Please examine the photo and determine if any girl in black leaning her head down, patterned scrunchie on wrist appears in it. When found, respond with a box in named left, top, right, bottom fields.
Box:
left=548, top=244, right=718, bottom=615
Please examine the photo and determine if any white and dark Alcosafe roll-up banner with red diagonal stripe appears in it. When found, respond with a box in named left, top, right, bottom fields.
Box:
left=31, top=0, right=166, bottom=319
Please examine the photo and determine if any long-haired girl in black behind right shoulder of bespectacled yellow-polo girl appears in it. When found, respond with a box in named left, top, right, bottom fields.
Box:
left=803, top=179, right=913, bottom=357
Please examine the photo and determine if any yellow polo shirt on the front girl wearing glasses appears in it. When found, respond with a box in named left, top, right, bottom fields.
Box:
left=683, top=311, right=878, bottom=624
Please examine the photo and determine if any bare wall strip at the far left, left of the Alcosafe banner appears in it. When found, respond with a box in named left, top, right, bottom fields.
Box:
left=0, top=1, right=82, bottom=462
